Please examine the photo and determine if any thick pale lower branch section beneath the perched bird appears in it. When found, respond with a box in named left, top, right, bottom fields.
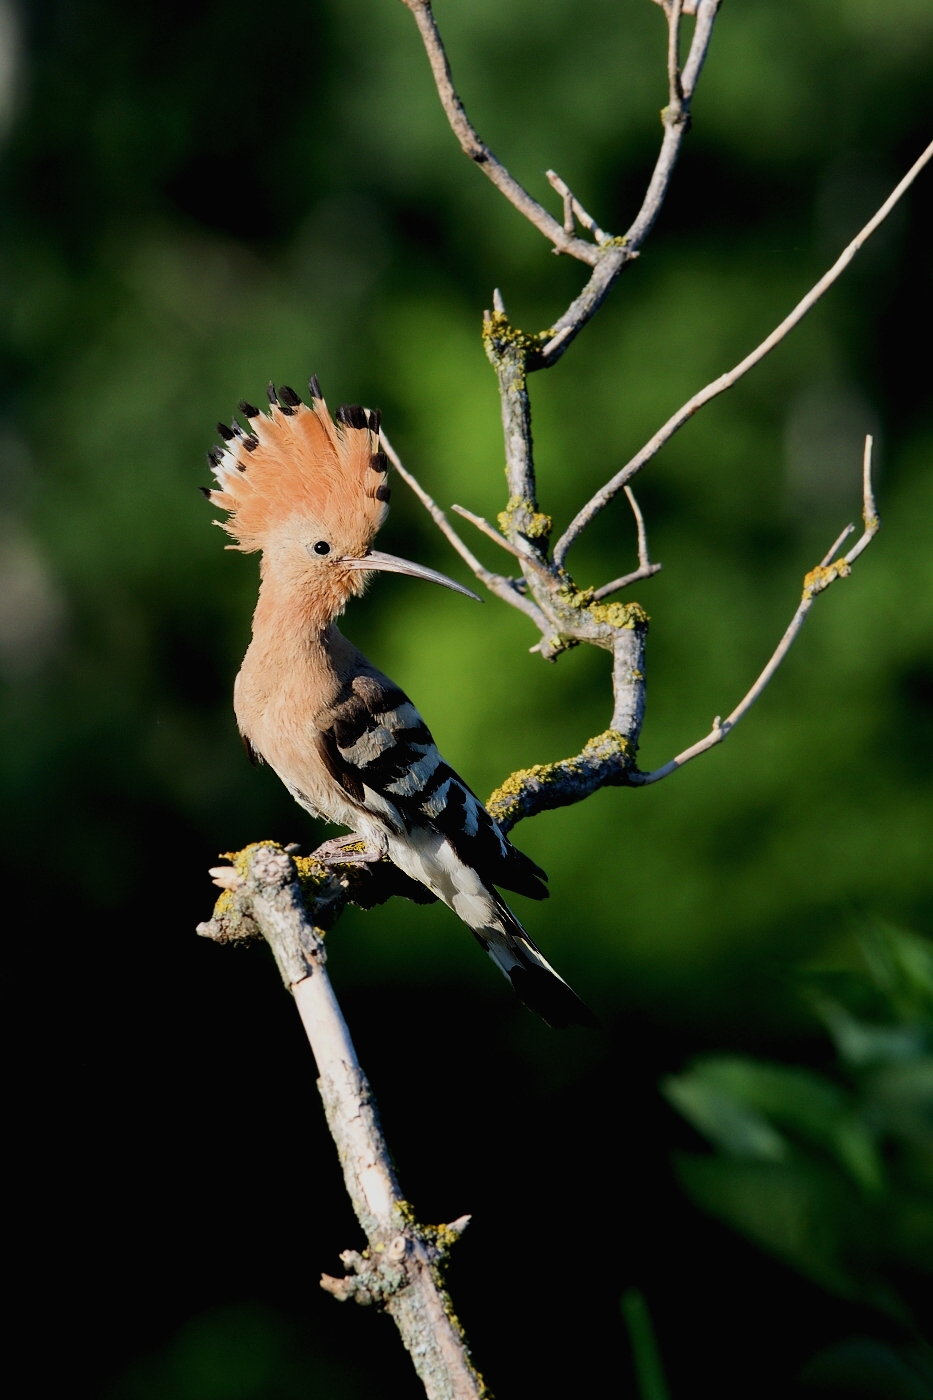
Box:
left=198, top=839, right=486, bottom=1400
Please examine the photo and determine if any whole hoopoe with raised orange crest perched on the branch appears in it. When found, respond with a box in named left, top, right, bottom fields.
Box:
left=202, top=377, right=595, bottom=1026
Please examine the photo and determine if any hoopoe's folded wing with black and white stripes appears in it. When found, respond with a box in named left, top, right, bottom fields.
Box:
left=321, top=672, right=548, bottom=899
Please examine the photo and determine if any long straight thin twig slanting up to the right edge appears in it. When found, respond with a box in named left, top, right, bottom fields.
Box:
left=553, top=141, right=933, bottom=568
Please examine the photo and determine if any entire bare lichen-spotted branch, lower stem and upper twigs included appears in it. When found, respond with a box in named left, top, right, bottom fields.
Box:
left=199, top=8, right=907, bottom=1400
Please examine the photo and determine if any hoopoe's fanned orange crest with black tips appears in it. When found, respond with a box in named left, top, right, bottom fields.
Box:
left=202, top=386, right=391, bottom=553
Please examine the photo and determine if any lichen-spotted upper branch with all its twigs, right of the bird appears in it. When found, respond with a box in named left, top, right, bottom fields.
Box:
left=389, top=0, right=918, bottom=829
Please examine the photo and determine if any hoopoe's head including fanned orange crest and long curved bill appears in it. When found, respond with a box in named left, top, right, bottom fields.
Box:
left=202, top=378, right=476, bottom=617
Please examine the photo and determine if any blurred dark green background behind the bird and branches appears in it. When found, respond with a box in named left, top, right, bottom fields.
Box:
left=0, top=0, right=933, bottom=1400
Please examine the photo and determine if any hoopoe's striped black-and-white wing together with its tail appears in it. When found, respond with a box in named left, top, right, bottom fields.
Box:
left=308, top=657, right=597, bottom=1028
